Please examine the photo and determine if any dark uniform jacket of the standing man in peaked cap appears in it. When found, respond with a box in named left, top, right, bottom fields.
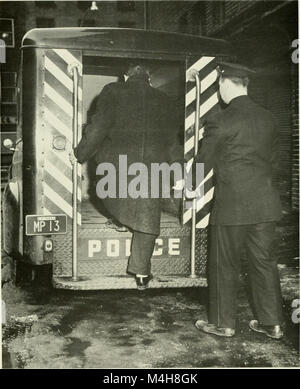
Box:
left=196, top=96, right=282, bottom=225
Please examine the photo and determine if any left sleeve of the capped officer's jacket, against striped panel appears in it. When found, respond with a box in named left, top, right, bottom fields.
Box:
left=193, top=117, right=225, bottom=187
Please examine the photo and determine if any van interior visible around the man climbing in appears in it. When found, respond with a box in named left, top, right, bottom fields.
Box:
left=81, top=56, right=185, bottom=228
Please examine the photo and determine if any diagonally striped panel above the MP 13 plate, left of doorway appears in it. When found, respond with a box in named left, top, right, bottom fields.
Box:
left=43, top=49, right=82, bottom=224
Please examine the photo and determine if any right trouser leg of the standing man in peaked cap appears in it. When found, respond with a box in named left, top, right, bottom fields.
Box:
left=246, top=222, right=283, bottom=326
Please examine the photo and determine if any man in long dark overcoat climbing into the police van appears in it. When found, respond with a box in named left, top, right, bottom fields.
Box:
left=71, top=63, right=178, bottom=289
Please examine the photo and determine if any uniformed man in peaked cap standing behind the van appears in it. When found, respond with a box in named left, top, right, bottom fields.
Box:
left=196, top=63, right=283, bottom=339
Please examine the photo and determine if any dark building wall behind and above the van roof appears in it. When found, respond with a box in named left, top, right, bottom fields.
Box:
left=0, top=0, right=299, bottom=209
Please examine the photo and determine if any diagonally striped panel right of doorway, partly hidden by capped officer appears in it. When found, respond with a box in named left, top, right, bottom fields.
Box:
left=183, top=56, right=219, bottom=228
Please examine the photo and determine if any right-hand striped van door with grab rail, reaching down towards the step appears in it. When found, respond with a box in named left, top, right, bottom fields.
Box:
left=182, top=56, right=220, bottom=277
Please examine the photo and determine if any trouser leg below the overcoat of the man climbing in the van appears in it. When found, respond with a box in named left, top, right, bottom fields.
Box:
left=127, top=231, right=157, bottom=275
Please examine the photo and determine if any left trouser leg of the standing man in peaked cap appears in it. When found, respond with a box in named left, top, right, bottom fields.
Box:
left=208, top=225, right=246, bottom=328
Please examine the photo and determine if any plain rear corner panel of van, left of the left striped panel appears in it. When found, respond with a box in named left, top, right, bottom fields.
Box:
left=22, top=48, right=52, bottom=265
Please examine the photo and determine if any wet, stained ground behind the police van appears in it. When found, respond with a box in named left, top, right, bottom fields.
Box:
left=2, top=265, right=299, bottom=369
